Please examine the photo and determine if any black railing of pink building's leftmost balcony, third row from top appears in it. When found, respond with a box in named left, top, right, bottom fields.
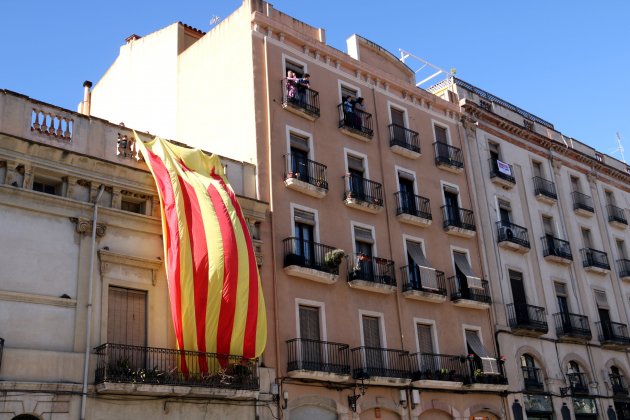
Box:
left=282, top=237, right=346, bottom=274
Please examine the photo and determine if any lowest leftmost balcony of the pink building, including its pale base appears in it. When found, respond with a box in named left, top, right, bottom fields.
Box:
left=287, top=338, right=350, bottom=382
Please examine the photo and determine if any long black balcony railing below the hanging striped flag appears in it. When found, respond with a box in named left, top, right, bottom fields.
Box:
left=94, top=343, right=259, bottom=390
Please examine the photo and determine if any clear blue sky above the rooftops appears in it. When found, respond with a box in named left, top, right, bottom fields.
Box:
left=0, top=0, right=630, bottom=161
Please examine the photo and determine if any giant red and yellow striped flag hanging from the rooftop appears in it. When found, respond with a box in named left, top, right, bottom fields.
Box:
left=136, top=135, right=267, bottom=372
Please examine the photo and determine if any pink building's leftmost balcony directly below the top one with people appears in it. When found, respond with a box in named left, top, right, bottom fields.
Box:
left=284, top=153, right=328, bottom=198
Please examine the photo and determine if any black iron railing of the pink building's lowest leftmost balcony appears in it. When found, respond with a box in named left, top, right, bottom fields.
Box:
left=287, top=338, right=350, bottom=375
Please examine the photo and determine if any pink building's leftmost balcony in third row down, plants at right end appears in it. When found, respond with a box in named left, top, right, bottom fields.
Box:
left=282, top=237, right=339, bottom=284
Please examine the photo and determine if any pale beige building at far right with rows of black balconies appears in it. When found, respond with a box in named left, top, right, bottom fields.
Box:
left=430, top=78, right=630, bottom=419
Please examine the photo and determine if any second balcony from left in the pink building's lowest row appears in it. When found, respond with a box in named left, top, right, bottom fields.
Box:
left=350, top=347, right=411, bottom=386
